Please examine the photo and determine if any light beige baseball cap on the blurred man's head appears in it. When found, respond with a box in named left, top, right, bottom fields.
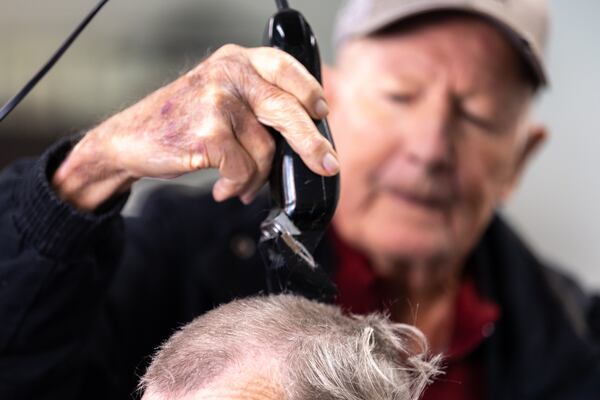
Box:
left=334, top=0, right=550, bottom=86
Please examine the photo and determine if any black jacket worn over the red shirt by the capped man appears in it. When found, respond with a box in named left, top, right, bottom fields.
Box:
left=0, top=138, right=600, bottom=400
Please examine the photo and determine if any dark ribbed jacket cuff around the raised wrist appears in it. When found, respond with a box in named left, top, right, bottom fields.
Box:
left=13, top=137, right=128, bottom=258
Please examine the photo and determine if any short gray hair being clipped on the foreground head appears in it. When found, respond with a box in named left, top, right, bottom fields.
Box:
left=140, top=295, right=439, bottom=400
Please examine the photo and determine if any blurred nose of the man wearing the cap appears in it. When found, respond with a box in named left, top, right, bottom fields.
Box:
left=403, top=95, right=454, bottom=172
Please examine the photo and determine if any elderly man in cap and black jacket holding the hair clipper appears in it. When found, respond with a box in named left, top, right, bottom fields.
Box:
left=0, top=0, right=600, bottom=399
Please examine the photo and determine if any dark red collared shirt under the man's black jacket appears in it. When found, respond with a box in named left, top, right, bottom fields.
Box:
left=331, top=234, right=500, bottom=400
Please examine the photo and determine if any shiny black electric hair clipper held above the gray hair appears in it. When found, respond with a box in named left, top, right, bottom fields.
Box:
left=259, top=1, right=339, bottom=301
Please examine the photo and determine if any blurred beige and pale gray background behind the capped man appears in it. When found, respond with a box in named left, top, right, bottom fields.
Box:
left=0, top=0, right=600, bottom=289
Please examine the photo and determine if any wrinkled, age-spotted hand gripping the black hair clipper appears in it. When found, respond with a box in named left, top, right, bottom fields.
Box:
left=52, top=45, right=339, bottom=210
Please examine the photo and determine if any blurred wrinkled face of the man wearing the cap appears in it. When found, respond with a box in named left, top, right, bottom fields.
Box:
left=326, top=17, right=541, bottom=272
